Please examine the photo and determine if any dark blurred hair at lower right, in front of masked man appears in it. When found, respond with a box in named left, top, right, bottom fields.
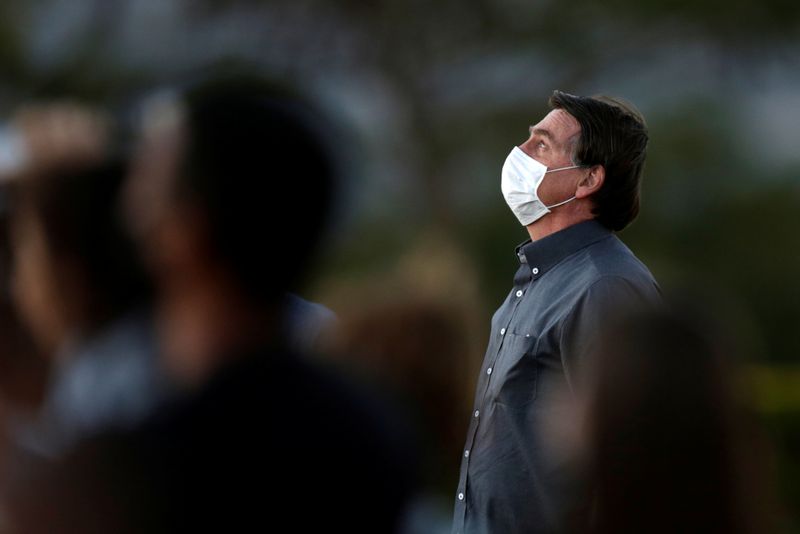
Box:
left=586, top=309, right=769, bottom=534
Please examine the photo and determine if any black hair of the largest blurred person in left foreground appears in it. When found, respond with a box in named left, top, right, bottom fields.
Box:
left=175, top=74, right=336, bottom=303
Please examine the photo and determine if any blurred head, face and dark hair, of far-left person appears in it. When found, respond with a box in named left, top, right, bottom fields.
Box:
left=11, top=159, right=149, bottom=352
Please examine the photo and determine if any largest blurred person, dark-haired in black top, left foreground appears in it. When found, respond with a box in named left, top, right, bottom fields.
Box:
left=1, top=76, right=413, bottom=532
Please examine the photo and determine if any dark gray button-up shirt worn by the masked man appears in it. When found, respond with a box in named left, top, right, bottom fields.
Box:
left=453, top=221, right=660, bottom=534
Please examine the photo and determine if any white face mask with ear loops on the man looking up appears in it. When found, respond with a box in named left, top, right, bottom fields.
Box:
left=500, top=146, right=581, bottom=226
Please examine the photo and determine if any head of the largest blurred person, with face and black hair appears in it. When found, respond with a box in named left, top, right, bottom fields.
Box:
left=127, top=74, right=335, bottom=386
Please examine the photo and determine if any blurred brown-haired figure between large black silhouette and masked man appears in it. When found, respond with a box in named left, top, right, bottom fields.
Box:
left=334, top=298, right=478, bottom=534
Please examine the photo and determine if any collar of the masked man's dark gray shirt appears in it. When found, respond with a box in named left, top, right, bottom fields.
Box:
left=516, top=219, right=611, bottom=278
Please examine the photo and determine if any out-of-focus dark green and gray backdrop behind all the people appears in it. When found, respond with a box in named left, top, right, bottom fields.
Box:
left=0, top=0, right=800, bottom=532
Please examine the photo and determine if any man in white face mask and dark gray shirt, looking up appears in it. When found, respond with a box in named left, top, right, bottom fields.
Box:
left=453, top=91, right=660, bottom=534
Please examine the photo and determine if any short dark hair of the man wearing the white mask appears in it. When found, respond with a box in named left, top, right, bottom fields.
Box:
left=550, top=91, right=648, bottom=231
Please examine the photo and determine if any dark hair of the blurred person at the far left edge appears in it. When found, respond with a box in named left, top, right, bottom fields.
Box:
left=10, top=158, right=151, bottom=334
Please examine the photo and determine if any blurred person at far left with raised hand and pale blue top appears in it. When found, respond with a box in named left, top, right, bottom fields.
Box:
left=3, top=103, right=167, bottom=460
